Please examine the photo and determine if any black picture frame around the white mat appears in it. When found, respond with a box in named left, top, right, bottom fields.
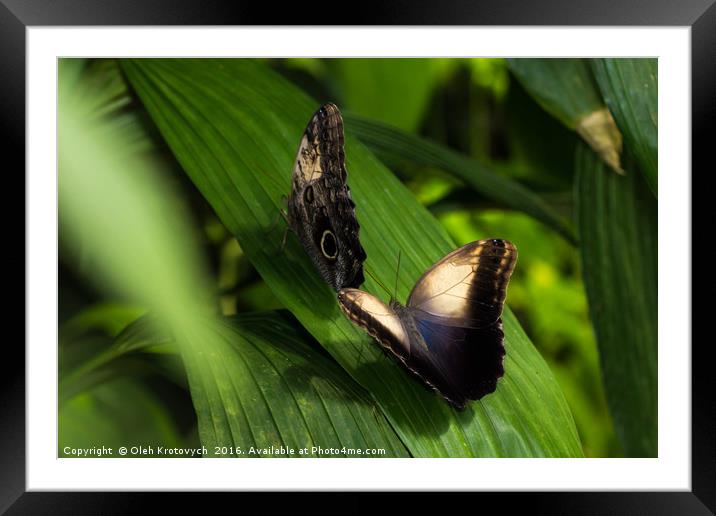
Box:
left=0, top=0, right=716, bottom=515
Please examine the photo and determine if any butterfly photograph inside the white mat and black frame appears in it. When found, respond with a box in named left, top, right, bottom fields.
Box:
left=57, top=58, right=658, bottom=459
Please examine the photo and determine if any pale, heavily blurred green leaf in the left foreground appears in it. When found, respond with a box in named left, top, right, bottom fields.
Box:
left=58, top=60, right=210, bottom=321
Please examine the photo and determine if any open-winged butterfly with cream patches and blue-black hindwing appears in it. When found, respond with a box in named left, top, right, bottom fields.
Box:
left=338, top=240, right=517, bottom=409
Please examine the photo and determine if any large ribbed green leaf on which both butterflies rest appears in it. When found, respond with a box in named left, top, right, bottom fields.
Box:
left=122, top=59, right=582, bottom=457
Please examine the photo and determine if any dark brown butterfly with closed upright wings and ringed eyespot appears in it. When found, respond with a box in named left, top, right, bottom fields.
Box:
left=288, top=103, right=366, bottom=291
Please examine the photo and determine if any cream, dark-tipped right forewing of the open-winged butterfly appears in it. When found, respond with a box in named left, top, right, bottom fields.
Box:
left=407, top=239, right=517, bottom=328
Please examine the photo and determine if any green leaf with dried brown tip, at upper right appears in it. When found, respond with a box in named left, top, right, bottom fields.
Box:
left=508, top=59, right=623, bottom=173
